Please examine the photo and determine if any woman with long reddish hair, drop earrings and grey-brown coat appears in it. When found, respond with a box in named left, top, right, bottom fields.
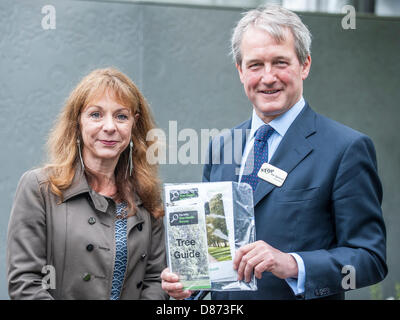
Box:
left=7, top=68, right=167, bottom=299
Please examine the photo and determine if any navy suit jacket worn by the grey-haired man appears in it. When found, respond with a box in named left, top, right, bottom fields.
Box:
left=203, top=103, right=387, bottom=299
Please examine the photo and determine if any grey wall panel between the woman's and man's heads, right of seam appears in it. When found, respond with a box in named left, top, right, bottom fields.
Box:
left=143, top=6, right=247, bottom=182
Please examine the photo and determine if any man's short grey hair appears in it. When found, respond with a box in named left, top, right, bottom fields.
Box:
left=231, top=5, right=311, bottom=65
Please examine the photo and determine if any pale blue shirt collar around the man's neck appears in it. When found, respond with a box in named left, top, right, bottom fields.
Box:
left=250, top=96, right=306, bottom=138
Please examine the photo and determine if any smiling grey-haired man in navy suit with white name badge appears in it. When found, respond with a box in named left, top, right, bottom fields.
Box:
left=162, top=6, right=387, bottom=299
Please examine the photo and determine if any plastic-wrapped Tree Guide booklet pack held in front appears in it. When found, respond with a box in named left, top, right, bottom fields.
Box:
left=164, top=182, right=255, bottom=290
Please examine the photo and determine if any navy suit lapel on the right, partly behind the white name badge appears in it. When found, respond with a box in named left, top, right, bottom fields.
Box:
left=254, top=103, right=316, bottom=206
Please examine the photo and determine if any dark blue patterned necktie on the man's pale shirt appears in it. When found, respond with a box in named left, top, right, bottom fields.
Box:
left=241, top=124, right=274, bottom=191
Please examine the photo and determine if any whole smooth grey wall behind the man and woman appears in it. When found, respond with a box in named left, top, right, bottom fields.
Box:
left=0, top=0, right=400, bottom=299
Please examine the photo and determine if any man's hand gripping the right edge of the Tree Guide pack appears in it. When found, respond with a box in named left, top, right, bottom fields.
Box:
left=233, top=240, right=298, bottom=282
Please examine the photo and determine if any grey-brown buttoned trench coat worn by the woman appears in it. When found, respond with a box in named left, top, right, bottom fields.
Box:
left=7, top=165, right=168, bottom=299
